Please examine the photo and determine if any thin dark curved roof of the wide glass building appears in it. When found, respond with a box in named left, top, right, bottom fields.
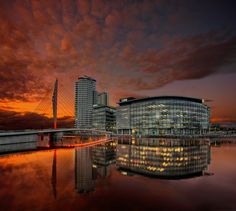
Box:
left=118, top=96, right=203, bottom=105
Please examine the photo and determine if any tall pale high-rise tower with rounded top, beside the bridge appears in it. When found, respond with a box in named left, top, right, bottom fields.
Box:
left=75, top=76, right=97, bottom=128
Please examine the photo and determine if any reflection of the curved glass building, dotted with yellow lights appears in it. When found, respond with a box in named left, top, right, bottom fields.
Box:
left=116, top=138, right=210, bottom=177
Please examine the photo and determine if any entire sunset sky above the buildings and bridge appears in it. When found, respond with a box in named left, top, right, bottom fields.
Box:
left=0, top=0, right=236, bottom=130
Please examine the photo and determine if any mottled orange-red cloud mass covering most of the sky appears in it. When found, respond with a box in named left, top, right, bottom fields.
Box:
left=0, top=0, right=236, bottom=129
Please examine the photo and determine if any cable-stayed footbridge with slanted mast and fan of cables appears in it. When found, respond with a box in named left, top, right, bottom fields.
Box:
left=0, top=80, right=112, bottom=152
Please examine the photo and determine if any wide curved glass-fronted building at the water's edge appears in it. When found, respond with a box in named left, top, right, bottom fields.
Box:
left=116, top=96, right=209, bottom=136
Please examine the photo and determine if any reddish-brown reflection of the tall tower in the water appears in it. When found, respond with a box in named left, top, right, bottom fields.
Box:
left=75, top=148, right=95, bottom=193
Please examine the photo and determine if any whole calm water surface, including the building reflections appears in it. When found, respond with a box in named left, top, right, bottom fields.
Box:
left=0, top=139, right=236, bottom=210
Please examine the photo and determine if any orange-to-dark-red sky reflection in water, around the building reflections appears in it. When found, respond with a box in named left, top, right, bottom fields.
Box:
left=0, top=145, right=236, bottom=210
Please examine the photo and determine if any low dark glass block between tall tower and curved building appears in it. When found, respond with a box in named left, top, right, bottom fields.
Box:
left=92, top=105, right=116, bottom=131
